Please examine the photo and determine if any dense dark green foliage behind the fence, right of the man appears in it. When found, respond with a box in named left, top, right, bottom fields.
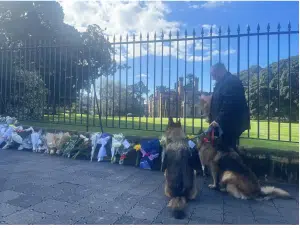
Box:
left=240, top=56, right=299, bottom=122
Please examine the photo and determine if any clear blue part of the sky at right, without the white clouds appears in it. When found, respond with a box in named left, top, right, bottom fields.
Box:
left=156, top=1, right=299, bottom=92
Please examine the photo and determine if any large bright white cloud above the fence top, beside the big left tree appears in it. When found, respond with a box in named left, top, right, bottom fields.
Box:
left=60, top=0, right=180, bottom=37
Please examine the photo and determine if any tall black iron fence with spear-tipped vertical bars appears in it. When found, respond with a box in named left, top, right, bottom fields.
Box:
left=0, top=24, right=299, bottom=142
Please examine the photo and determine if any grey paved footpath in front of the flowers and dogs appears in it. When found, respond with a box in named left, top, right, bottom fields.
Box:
left=0, top=150, right=299, bottom=225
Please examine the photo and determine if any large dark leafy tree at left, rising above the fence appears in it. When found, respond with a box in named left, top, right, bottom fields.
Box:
left=0, top=1, right=115, bottom=118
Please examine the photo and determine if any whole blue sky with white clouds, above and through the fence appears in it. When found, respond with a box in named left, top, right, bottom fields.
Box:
left=60, top=0, right=299, bottom=94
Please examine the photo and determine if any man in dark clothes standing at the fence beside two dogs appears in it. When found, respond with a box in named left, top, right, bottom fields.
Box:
left=209, top=63, right=250, bottom=151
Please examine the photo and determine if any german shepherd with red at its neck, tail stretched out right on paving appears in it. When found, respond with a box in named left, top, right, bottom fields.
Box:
left=197, top=135, right=291, bottom=200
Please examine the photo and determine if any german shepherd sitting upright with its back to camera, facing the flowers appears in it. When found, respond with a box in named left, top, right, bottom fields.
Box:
left=163, top=118, right=198, bottom=219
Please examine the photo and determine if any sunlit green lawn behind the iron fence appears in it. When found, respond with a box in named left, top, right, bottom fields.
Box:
left=22, top=113, right=299, bottom=152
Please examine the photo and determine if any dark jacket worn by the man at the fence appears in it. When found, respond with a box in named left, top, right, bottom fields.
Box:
left=210, top=72, right=250, bottom=137
